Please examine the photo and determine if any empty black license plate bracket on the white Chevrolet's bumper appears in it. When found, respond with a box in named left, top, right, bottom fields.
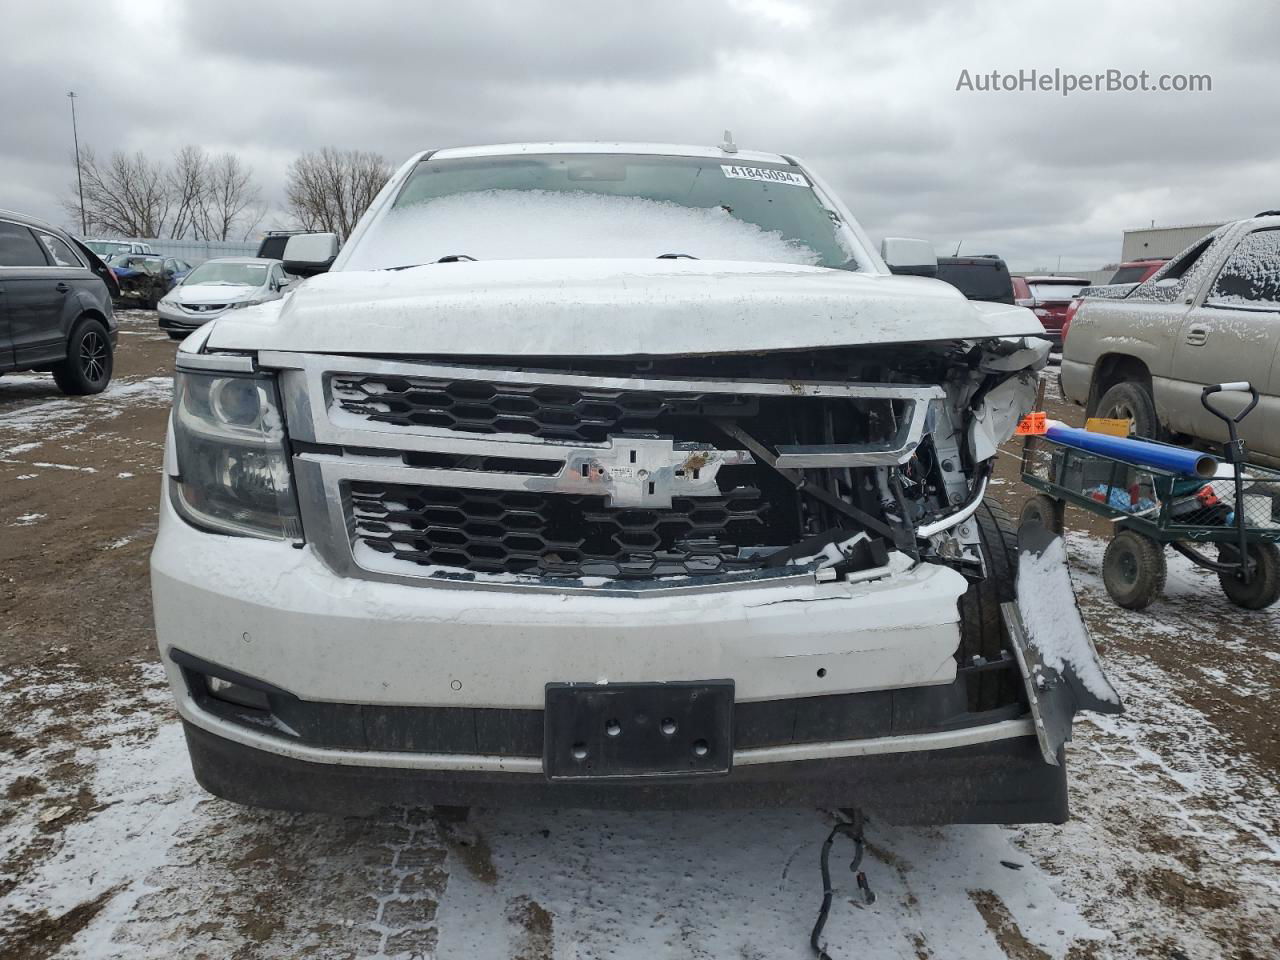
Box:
left=543, top=680, right=733, bottom=781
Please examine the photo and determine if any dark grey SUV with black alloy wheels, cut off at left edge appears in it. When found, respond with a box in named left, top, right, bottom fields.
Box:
left=0, top=210, right=116, bottom=394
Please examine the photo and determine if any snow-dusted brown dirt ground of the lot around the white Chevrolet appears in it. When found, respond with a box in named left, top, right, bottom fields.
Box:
left=0, top=311, right=1280, bottom=960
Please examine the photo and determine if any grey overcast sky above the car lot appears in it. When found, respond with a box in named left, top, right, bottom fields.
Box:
left=0, top=0, right=1280, bottom=269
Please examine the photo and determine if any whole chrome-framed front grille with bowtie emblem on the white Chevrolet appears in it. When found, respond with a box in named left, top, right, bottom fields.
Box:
left=296, top=356, right=943, bottom=589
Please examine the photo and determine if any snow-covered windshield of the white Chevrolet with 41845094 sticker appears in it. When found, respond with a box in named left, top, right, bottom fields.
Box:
left=347, top=154, right=859, bottom=270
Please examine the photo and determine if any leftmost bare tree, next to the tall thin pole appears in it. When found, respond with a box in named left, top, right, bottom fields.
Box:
left=63, top=147, right=172, bottom=237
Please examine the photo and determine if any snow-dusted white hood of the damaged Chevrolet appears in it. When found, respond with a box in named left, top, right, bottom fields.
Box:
left=206, top=260, right=1043, bottom=356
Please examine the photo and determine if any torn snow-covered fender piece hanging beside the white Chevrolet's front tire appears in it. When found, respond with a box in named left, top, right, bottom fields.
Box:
left=1001, top=524, right=1124, bottom=767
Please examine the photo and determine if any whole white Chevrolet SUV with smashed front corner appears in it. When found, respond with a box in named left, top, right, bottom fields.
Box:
left=151, top=143, right=1117, bottom=823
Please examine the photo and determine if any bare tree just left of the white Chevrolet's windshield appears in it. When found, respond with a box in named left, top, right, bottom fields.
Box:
left=284, top=147, right=392, bottom=237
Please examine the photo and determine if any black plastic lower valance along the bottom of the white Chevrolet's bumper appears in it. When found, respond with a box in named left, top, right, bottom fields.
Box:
left=183, top=721, right=1068, bottom=824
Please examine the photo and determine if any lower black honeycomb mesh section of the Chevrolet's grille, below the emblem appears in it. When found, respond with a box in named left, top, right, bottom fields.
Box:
left=347, top=483, right=778, bottom=580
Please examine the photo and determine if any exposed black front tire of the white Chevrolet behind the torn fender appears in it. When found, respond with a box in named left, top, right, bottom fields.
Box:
left=956, top=500, right=1021, bottom=712
